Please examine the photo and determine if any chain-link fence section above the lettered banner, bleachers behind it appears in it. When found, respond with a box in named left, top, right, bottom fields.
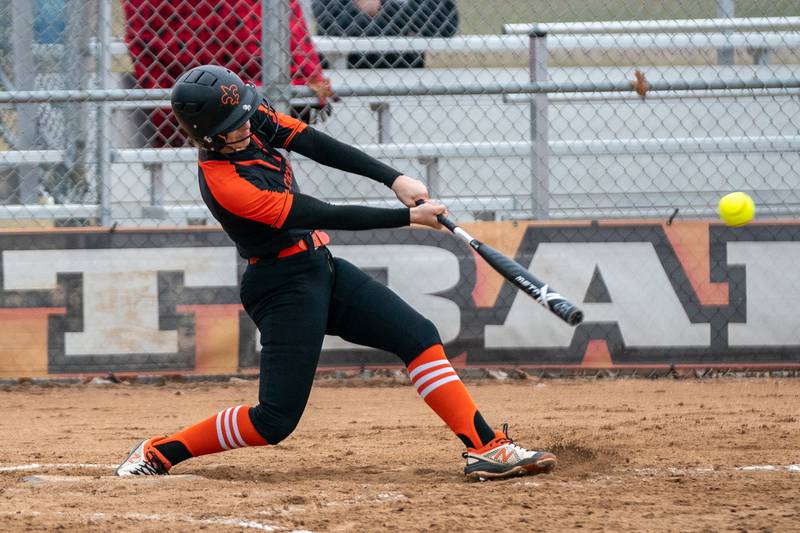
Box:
left=0, top=0, right=800, bottom=227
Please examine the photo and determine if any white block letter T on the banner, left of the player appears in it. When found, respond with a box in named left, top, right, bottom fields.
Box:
left=3, top=247, right=237, bottom=356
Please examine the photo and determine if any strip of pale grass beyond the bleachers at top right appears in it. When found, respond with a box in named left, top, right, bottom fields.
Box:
left=457, top=0, right=800, bottom=35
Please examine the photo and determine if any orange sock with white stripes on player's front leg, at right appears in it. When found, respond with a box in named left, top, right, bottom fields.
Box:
left=408, top=344, right=499, bottom=448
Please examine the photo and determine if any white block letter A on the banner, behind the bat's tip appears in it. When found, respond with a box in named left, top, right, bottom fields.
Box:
left=485, top=242, right=710, bottom=348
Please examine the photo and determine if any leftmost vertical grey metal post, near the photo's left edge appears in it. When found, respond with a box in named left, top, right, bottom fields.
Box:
left=9, top=0, right=41, bottom=204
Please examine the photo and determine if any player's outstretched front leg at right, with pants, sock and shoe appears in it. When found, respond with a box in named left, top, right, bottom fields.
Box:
left=328, top=258, right=556, bottom=479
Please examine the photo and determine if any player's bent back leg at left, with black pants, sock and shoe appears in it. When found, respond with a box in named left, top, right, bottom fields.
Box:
left=117, top=250, right=332, bottom=476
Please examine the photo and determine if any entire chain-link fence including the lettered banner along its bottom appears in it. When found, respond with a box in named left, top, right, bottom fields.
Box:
left=0, top=0, right=800, bottom=375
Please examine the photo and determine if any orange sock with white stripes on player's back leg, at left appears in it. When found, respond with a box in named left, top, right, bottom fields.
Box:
left=152, top=405, right=267, bottom=466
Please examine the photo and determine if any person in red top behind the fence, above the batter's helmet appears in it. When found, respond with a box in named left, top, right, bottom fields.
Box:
left=122, top=0, right=337, bottom=147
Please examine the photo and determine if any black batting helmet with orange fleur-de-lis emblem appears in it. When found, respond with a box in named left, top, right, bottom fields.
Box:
left=171, top=65, right=260, bottom=150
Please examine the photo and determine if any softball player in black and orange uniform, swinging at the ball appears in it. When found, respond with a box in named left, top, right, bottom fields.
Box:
left=116, top=65, right=556, bottom=479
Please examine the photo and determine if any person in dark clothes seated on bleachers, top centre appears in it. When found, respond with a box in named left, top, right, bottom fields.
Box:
left=312, top=0, right=458, bottom=68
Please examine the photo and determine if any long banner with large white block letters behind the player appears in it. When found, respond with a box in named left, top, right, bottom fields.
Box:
left=0, top=222, right=800, bottom=377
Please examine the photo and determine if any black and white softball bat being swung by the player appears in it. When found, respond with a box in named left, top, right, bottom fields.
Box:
left=417, top=200, right=583, bottom=326
